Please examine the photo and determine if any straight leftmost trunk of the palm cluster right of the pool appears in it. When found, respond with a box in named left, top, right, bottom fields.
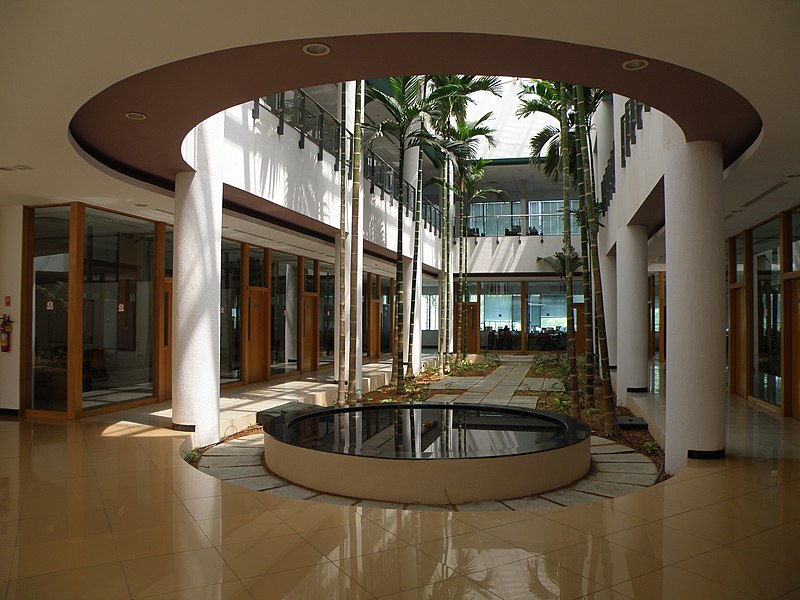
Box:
left=558, top=83, right=581, bottom=419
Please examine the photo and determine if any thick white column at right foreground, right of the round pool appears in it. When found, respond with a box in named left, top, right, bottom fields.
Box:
left=664, top=127, right=726, bottom=473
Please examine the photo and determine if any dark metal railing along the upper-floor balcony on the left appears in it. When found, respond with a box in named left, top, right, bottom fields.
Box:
left=260, top=90, right=441, bottom=234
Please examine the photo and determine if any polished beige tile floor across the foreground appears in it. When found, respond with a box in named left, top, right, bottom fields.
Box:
left=0, top=358, right=800, bottom=600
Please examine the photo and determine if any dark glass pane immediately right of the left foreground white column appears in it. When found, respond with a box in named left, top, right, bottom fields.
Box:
left=219, top=240, right=242, bottom=383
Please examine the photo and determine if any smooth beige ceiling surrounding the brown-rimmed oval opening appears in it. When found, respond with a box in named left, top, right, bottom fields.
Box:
left=0, top=0, right=800, bottom=248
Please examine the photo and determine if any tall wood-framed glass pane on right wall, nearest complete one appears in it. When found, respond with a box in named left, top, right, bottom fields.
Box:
left=753, top=219, right=781, bottom=406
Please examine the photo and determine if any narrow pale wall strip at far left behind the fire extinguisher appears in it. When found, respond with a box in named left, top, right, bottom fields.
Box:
left=0, top=206, right=23, bottom=410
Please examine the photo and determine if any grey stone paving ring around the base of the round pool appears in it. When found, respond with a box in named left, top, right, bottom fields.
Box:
left=198, top=433, right=659, bottom=511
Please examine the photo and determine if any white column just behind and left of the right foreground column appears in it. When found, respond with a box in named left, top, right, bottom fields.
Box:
left=617, top=225, right=648, bottom=398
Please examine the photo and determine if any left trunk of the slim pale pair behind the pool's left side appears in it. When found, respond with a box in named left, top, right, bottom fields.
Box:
left=336, top=81, right=347, bottom=405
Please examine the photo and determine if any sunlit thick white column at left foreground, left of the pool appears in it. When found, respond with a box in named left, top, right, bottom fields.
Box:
left=172, top=113, right=224, bottom=446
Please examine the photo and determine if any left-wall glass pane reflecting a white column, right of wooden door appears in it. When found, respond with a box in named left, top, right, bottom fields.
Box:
left=276, top=251, right=298, bottom=375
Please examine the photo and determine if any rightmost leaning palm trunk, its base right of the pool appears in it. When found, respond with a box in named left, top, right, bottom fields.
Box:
left=576, top=85, right=619, bottom=435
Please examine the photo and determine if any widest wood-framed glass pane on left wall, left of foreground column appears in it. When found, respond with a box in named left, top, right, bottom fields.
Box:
left=83, top=208, right=155, bottom=410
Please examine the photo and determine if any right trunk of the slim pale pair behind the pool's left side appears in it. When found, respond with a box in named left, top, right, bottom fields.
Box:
left=342, top=79, right=364, bottom=400
